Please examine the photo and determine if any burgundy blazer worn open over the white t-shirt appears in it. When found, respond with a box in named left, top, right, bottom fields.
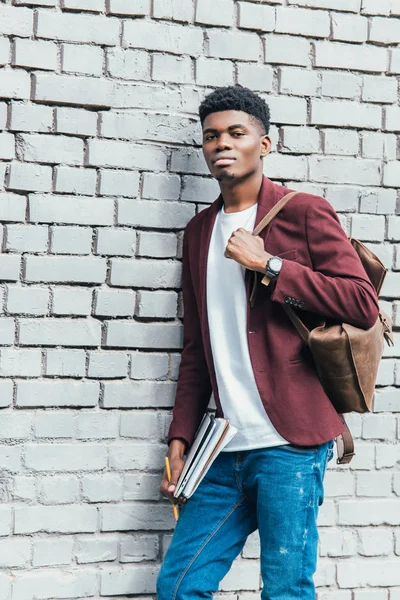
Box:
left=168, top=177, right=378, bottom=446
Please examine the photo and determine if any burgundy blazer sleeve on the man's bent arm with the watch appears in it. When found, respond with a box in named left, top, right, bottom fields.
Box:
left=271, top=198, right=379, bottom=329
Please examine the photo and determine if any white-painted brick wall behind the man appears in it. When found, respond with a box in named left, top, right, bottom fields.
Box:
left=0, top=0, right=400, bottom=600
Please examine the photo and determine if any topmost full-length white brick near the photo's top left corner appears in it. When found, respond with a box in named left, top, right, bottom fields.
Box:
left=36, top=10, right=119, bottom=46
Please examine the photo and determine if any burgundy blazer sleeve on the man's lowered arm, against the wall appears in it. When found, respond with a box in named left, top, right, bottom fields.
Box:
left=168, top=230, right=211, bottom=447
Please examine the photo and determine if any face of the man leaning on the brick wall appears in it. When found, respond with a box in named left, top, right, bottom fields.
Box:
left=203, top=110, right=271, bottom=181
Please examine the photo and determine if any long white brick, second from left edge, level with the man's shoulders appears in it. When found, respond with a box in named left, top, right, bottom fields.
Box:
left=29, top=194, right=114, bottom=225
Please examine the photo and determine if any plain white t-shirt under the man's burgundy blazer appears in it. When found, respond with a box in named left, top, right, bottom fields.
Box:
left=207, top=204, right=288, bottom=451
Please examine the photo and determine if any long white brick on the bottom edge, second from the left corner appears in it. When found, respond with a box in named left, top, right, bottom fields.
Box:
left=13, top=568, right=98, bottom=600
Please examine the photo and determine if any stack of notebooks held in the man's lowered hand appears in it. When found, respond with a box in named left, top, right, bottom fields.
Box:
left=174, top=413, right=237, bottom=498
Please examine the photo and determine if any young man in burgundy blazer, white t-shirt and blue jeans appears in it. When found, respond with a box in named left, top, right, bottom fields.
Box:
left=158, top=86, right=378, bottom=600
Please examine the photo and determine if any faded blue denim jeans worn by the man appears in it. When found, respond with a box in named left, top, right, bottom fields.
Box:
left=157, top=442, right=333, bottom=600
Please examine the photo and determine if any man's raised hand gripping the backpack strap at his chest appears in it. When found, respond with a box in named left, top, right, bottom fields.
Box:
left=224, top=227, right=272, bottom=273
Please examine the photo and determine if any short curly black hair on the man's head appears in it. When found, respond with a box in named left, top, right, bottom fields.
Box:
left=199, top=85, right=270, bottom=135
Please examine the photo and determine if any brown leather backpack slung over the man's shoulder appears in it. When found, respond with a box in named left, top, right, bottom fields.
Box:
left=250, top=192, right=393, bottom=464
